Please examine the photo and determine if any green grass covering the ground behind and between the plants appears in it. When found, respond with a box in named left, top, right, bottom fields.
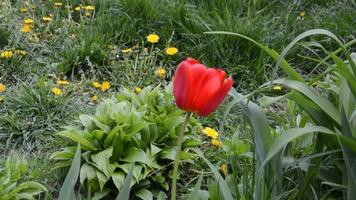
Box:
left=0, top=0, right=356, bottom=199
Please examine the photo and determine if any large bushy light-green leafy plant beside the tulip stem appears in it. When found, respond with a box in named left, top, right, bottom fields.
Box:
left=52, top=87, right=200, bottom=199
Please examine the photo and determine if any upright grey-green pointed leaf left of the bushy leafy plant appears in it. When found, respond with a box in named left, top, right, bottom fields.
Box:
left=58, top=144, right=81, bottom=200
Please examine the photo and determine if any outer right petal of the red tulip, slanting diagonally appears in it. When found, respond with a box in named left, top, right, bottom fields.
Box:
left=198, top=78, right=233, bottom=117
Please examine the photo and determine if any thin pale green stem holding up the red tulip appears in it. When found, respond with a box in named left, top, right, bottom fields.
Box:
left=171, top=113, right=191, bottom=200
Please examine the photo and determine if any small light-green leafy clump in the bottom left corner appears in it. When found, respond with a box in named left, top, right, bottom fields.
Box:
left=0, top=155, right=47, bottom=200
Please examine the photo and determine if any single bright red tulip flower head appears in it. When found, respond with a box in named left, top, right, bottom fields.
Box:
left=173, top=58, right=233, bottom=117
